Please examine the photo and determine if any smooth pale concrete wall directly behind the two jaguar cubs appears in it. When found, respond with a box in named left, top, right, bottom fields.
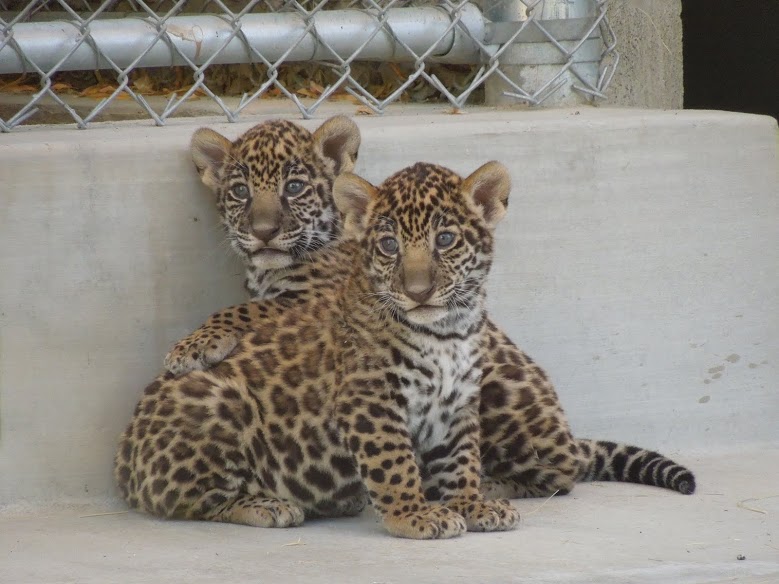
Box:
left=0, top=108, right=779, bottom=504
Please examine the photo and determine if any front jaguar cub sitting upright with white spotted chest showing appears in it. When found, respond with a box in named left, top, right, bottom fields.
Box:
left=115, top=162, right=519, bottom=539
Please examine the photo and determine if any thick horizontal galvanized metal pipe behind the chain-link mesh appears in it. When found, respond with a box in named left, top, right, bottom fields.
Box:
left=0, top=4, right=485, bottom=74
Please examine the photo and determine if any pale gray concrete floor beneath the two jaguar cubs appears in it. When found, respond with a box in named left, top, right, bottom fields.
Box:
left=0, top=445, right=779, bottom=584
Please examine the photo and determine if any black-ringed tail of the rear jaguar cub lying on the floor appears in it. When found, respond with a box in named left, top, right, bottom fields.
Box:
left=577, top=438, right=695, bottom=495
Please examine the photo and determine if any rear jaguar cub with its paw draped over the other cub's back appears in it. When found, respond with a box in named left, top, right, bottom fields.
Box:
left=165, top=117, right=695, bottom=497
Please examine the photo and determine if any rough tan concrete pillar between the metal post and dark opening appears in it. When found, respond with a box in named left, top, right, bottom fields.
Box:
left=606, top=0, right=684, bottom=109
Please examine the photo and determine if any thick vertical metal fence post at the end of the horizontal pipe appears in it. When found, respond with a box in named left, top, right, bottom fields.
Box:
left=481, top=0, right=602, bottom=107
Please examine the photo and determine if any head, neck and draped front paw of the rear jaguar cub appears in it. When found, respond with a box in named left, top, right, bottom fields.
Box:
left=165, top=116, right=360, bottom=364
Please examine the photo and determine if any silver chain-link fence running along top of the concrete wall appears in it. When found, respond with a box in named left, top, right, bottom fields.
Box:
left=0, top=0, right=619, bottom=132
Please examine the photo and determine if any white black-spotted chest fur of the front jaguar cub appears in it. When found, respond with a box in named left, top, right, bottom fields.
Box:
left=403, top=335, right=481, bottom=451
